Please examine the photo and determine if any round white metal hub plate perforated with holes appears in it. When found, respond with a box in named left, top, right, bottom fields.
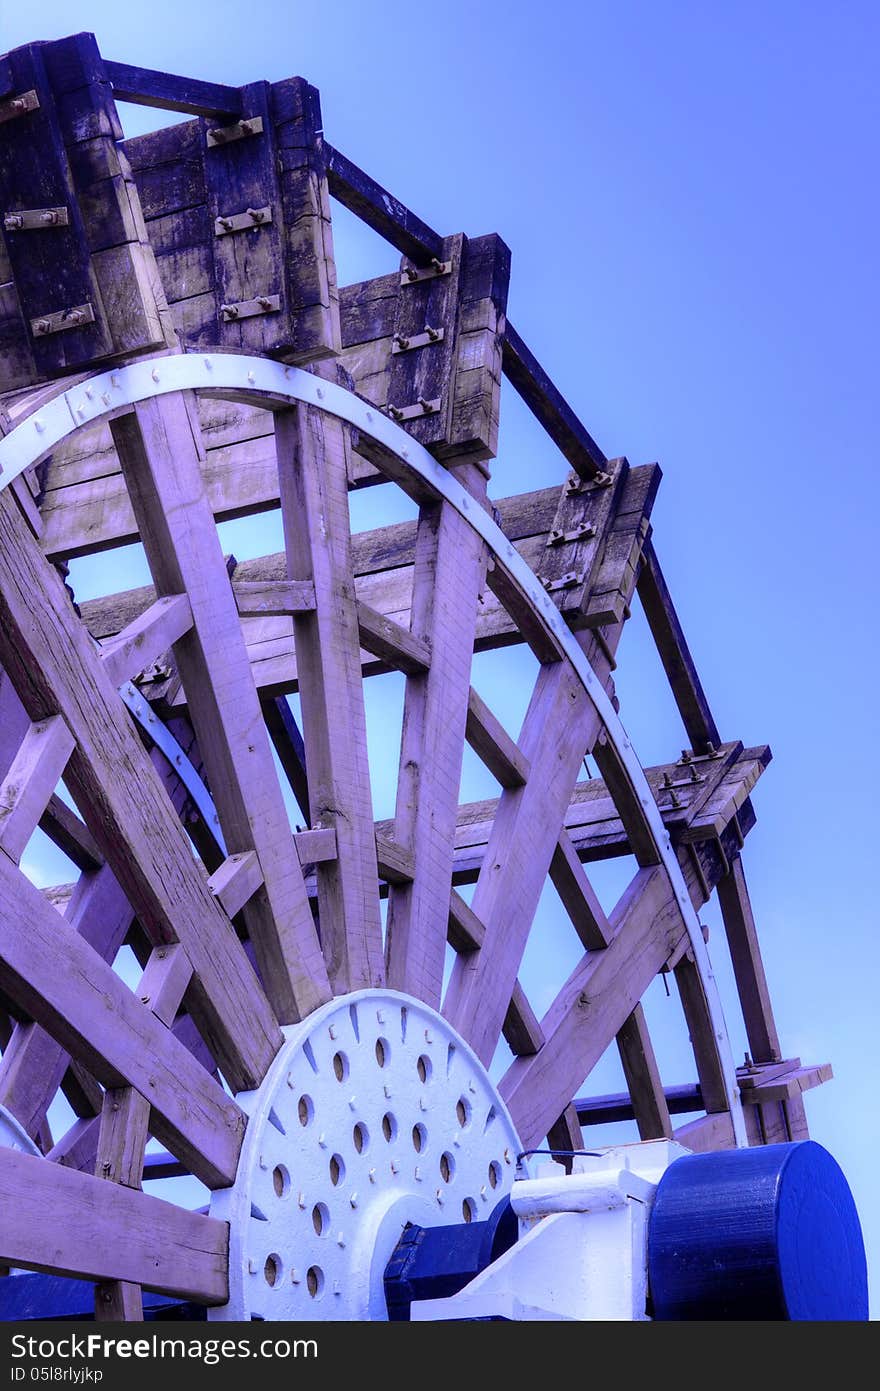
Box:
left=209, top=990, right=520, bottom=1320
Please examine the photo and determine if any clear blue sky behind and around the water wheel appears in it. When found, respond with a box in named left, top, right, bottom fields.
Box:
left=0, top=0, right=880, bottom=1318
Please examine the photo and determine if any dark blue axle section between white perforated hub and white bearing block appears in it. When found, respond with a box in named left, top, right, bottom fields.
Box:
left=385, top=1198, right=520, bottom=1323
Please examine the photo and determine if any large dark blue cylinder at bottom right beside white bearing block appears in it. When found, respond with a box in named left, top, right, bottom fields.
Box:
left=648, top=1141, right=867, bottom=1321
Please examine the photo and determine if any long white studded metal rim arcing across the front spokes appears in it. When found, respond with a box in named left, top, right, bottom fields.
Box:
left=0, top=353, right=748, bottom=1146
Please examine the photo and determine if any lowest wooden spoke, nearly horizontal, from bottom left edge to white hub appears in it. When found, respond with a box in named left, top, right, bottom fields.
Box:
left=0, top=1149, right=228, bottom=1303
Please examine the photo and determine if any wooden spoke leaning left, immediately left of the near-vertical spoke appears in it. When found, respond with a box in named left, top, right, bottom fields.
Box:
left=111, top=394, right=331, bottom=1022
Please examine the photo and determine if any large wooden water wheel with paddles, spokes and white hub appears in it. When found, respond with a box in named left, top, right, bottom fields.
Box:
left=0, top=35, right=827, bottom=1319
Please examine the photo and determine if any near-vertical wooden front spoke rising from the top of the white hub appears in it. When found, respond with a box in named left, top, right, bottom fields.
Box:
left=275, top=397, right=385, bottom=993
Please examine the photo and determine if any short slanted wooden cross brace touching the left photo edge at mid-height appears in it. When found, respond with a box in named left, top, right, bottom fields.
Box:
left=0, top=715, right=74, bottom=864
